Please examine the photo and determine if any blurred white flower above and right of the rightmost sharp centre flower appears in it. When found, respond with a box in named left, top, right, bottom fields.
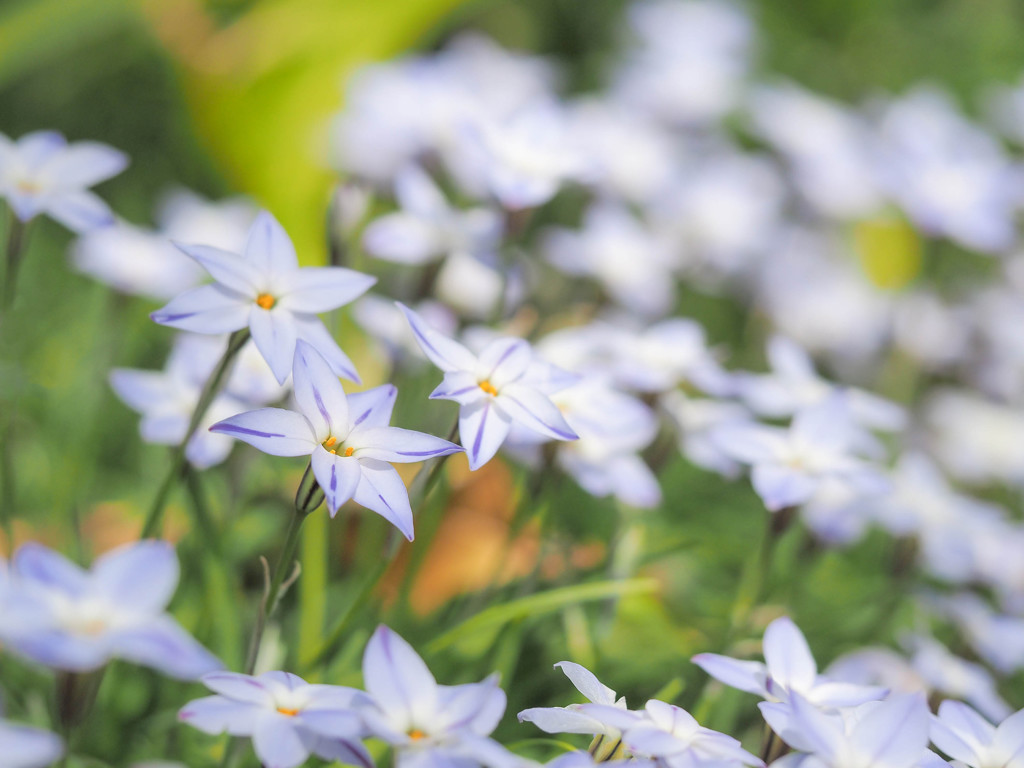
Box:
left=543, top=203, right=676, bottom=317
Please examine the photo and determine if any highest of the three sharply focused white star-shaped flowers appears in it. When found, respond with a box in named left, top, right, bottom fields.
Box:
left=151, top=211, right=377, bottom=384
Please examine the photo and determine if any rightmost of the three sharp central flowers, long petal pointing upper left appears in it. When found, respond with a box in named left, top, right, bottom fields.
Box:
left=398, top=304, right=579, bottom=469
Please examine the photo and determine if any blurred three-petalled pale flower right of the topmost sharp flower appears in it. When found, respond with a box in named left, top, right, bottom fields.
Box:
left=362, top=166, right=502, bottom=264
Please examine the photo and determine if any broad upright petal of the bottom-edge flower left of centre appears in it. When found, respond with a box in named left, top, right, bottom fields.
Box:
left=362, top=625, right=438, bottom=731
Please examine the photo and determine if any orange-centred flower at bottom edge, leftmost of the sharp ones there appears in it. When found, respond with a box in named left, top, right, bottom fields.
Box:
left=178, top=672, right=374, bottom=768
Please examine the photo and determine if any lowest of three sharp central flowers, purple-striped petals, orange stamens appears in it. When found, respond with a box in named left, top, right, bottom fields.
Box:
left=210, top=340, right=462, bottom=541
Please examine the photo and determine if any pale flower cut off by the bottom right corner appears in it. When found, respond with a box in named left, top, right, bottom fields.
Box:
left=931, top=700, right=1024, bottom=768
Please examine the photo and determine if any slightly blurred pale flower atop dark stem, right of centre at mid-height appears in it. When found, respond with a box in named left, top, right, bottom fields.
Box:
left=714, top=395, right=888, bottom=512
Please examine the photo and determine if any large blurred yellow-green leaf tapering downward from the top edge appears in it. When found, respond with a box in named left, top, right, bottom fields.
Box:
left=146, top=0, right=464, bottom=263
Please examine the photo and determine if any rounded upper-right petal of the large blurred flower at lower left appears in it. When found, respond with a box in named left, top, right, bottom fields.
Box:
left=91, top=540, right=179, bottom=613
